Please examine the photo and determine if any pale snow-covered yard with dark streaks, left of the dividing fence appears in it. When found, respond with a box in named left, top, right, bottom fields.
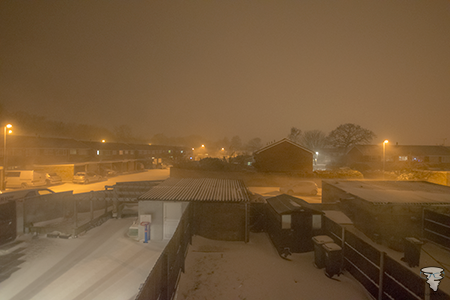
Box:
left=0, top=218, right=166, bottom=300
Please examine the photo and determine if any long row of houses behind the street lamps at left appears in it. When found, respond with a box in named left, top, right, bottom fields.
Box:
left=0, top=135, right=192, bottom=180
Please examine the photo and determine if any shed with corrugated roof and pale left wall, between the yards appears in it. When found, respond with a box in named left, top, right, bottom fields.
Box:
left=138, top=178, right=249, bottom=241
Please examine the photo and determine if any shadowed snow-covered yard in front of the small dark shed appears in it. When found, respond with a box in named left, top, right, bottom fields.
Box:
left=177, top=233, right=372, bottom=300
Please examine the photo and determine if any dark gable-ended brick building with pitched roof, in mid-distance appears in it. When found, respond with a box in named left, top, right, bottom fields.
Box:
left=253, top=138, right=314, bottom=173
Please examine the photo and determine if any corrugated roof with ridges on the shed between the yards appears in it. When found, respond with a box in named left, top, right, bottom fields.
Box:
left=139, top=178, right=249, bottom=202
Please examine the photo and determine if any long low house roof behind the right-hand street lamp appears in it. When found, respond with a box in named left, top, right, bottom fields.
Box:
left=349, top=144, right=450, bottom=156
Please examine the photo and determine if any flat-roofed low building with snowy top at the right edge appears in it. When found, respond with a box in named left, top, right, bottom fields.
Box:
left=322, top=180, right=450, bottom=245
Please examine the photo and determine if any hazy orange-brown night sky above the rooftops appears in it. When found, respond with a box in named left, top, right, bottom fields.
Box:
left=0, top=0, right=450, bottom=146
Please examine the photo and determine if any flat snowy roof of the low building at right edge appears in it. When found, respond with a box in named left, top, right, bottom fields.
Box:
left=323, top=180, right=450, bottom=205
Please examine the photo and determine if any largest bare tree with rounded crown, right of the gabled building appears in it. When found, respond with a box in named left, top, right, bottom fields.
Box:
left=328, top=123, right=376, bottom=149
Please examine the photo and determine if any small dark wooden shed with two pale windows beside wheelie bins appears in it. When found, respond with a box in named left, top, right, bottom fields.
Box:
left=266, top=194, right=324, bottom=255
